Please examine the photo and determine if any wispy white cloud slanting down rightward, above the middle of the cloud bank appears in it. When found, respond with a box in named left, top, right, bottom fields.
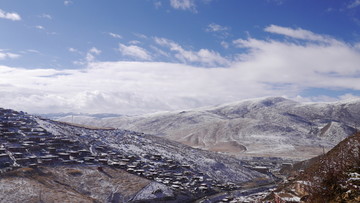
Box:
left=155, top=37, right=229, bottom=66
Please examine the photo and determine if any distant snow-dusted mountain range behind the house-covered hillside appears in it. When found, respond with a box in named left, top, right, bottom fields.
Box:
left=58, top=97, right=360, bottom=159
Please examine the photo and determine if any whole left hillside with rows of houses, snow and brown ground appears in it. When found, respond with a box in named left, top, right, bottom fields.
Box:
left=0, top=109, right=271, bottom=202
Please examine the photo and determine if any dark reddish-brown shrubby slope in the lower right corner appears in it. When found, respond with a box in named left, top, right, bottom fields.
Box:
left=267, top=133, right=360, bottom=203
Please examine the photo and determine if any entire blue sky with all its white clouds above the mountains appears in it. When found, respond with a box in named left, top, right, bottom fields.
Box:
left=0, top=0, right=360, bottom=114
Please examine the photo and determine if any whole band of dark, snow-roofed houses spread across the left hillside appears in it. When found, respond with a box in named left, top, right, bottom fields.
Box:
left=0, top=108, right=237, bottom=196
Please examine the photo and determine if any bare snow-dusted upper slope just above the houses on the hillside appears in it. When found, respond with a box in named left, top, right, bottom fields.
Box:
left=38, top=120, right=267, bottom=184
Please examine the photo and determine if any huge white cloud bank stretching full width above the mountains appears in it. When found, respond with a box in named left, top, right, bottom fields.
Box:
left=0, top=25, right=360, bottom=114
